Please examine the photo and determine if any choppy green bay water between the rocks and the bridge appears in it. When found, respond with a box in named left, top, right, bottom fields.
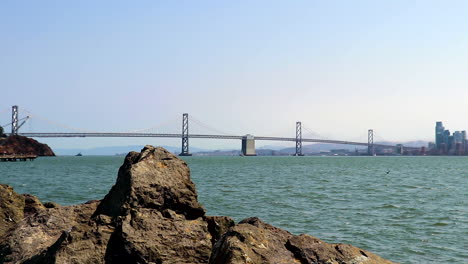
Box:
left=0, top=156, right=468, bottom=263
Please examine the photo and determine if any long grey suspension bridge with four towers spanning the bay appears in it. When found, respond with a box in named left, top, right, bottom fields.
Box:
left=3, top=105, right=425, bottom=156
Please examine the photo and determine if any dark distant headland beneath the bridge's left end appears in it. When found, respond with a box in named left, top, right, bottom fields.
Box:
left=0, top=135, right=55, bottom=156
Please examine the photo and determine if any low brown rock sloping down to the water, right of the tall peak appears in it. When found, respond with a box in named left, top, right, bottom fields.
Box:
left=209, top=218, right=393, bottom=264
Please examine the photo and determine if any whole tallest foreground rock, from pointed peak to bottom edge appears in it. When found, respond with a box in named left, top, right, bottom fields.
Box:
left=41, top=146, right=212, bottom=263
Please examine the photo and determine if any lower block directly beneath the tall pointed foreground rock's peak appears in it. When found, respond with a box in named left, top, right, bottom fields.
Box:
left=106, top=208, right=212, bottom=264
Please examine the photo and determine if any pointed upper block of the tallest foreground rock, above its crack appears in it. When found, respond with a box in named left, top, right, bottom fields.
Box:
left=95, top=146, right=205, bottom=219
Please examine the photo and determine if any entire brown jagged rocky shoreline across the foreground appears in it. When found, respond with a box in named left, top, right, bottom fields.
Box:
left=0, top=146, right=393, bottom=264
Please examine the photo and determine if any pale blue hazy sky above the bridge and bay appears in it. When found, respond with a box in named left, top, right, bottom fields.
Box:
left=0, top=0, right=468, bottom=151
